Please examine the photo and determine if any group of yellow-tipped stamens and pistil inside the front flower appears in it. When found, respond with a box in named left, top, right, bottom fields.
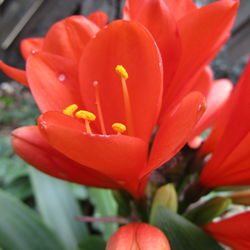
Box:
left=63, top=65, right=131, bottom=135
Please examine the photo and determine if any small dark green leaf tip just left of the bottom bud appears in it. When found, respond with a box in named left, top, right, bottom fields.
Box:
left=79, top=235, right=106, bottom=250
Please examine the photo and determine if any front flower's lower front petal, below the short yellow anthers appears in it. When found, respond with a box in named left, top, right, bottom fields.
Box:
left=39, top=112, right=147, bottom=183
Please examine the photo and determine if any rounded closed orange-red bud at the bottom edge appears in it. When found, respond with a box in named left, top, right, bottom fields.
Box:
left=106, top=223, right=170, bottom=250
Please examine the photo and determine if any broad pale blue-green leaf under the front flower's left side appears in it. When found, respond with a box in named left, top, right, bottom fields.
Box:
left=30, top=168, right=88, bottom=250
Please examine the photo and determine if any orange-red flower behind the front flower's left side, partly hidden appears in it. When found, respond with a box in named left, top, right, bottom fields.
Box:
left=0, top=12, right=104, bottom=87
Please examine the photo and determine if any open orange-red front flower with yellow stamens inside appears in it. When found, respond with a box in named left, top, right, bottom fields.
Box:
left=9, top=21, right=204, bottom=197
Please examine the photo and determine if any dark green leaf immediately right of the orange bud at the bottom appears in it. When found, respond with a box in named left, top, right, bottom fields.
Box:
left=151, top=207, right=223, bottom=250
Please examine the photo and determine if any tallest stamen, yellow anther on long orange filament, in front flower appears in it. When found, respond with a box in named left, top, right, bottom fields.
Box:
left=115, top=65, right=134, bottom=136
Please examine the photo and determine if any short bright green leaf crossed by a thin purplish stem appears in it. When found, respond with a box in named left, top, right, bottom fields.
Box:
left=89, top=188, right=118, bottom=240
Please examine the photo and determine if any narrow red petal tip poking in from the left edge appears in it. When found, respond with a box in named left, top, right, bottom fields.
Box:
left=0, top=61, right=29, bottom=87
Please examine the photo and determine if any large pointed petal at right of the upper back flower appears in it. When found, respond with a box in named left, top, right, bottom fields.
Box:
left=163, top=0, right=239, bottom=110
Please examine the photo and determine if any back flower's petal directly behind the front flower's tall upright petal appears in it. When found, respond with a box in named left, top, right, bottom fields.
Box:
left=125, top=0, right=181, bottom=84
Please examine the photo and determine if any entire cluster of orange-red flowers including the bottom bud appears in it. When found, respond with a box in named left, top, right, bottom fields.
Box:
left=0, top=0, right=250, bottom=250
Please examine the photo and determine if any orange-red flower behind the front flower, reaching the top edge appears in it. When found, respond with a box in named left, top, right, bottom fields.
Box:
left=124, top=0, right=239, bottom=143
